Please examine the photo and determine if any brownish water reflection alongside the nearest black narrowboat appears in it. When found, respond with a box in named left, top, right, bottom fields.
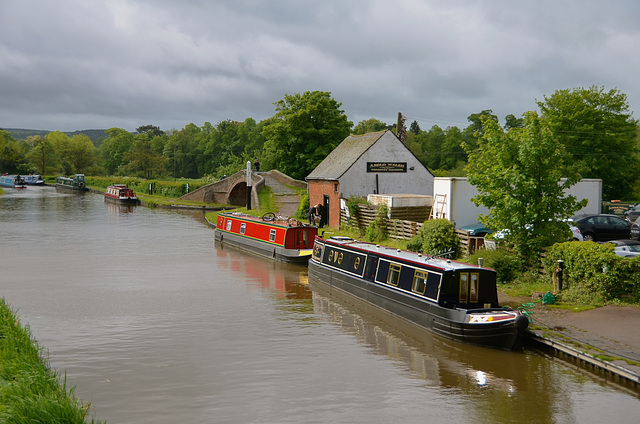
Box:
left=310, top=281, right=620, bottom=423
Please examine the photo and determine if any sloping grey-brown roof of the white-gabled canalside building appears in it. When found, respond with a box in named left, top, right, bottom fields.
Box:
left=306, top=130, right=388, bottom=180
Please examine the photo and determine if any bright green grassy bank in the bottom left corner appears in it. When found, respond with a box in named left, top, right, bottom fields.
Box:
left=0, top=298, right=99, bottom=424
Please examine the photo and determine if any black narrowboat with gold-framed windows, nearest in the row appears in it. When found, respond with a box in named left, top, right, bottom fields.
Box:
left=309, top=237, right=529, bottom=350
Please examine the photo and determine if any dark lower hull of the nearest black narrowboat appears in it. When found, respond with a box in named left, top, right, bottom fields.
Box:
left=309, top=260, right=528, bottom=350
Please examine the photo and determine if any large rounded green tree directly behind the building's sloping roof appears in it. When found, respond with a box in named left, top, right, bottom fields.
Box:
left=262, top=91, right=353, bottom=179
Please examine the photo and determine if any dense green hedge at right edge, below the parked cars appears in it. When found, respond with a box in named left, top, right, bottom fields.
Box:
left=543, top=241, right=640, bottom=304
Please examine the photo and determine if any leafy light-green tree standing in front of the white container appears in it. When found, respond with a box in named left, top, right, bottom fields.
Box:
left=465, top=112, right=586, bottom=265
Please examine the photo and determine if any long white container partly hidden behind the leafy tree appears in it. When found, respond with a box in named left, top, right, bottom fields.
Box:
left=433, top=177, right=602, bottom=228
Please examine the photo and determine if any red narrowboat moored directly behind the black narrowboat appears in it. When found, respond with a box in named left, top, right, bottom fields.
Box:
left=215, top=212, right=318, bottom=265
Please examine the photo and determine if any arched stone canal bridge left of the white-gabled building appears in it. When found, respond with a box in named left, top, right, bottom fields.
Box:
left=181, top=169, right=307, bottom=216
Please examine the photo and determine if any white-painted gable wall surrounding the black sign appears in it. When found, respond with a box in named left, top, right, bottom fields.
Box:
left=340, top=133, right=433, bottom=198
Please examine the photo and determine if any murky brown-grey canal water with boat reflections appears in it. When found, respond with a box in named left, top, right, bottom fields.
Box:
left=0, top=187, right=640, bottom=424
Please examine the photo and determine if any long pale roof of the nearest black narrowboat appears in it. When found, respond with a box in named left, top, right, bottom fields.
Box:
left=325, top=236, right=491, bottom=270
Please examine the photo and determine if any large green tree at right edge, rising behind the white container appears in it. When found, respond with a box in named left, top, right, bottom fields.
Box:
left=537, top=86, right=640, bottom=199
